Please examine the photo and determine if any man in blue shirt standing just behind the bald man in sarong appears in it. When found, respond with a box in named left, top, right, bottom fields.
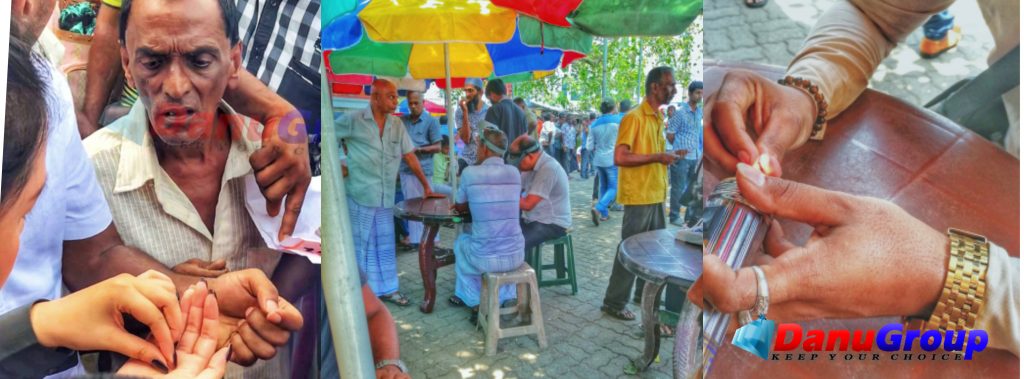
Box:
left=398, top=91, right=444, bottom=247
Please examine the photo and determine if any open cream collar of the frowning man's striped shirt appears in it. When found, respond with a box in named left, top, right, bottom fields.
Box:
left=114, top=100, right=262, bottom=194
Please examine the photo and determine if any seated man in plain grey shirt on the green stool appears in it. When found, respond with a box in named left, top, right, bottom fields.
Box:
left=509, top=135, right=572, bottom=250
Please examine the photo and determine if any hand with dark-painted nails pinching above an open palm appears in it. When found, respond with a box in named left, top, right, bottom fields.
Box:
left=31, top=270, right=185, bottom=367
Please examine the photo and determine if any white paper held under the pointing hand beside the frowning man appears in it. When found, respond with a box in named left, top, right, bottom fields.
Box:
left=246, top=174, right=321, bottom=264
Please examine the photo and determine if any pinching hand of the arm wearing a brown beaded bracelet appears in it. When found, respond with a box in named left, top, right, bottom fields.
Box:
left=703, top=70, right=817, bottom=176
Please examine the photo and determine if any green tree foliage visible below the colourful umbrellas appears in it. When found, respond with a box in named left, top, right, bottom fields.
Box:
left=514, top=16, right=703, bottom=112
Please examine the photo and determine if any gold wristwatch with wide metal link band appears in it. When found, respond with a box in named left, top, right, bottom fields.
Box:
left=905, top=227, right=988, bottom=331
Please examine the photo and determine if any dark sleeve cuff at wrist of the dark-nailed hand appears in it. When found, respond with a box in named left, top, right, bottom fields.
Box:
left=0, top=302, right=78, bottom=378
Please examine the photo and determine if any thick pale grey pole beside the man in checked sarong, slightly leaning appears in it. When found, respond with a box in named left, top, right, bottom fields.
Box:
left=317, top=64, right=374, bottom=379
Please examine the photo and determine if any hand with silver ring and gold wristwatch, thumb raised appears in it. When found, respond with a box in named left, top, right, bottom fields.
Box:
left=688, top=164, right=949, bottom=322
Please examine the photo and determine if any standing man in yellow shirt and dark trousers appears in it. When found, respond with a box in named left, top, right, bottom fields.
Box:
left=601, top=67, right=685, bottom=321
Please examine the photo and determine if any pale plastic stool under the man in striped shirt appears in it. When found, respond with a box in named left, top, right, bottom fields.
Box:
left=476, top=262, right=548, bottom=355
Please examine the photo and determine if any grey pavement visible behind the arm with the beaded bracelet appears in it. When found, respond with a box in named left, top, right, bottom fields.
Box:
left=705, top=0, right=993, bottom=106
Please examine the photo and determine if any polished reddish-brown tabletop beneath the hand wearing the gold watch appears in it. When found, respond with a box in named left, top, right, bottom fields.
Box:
left=703, top=60, right=1020, bottom=378
